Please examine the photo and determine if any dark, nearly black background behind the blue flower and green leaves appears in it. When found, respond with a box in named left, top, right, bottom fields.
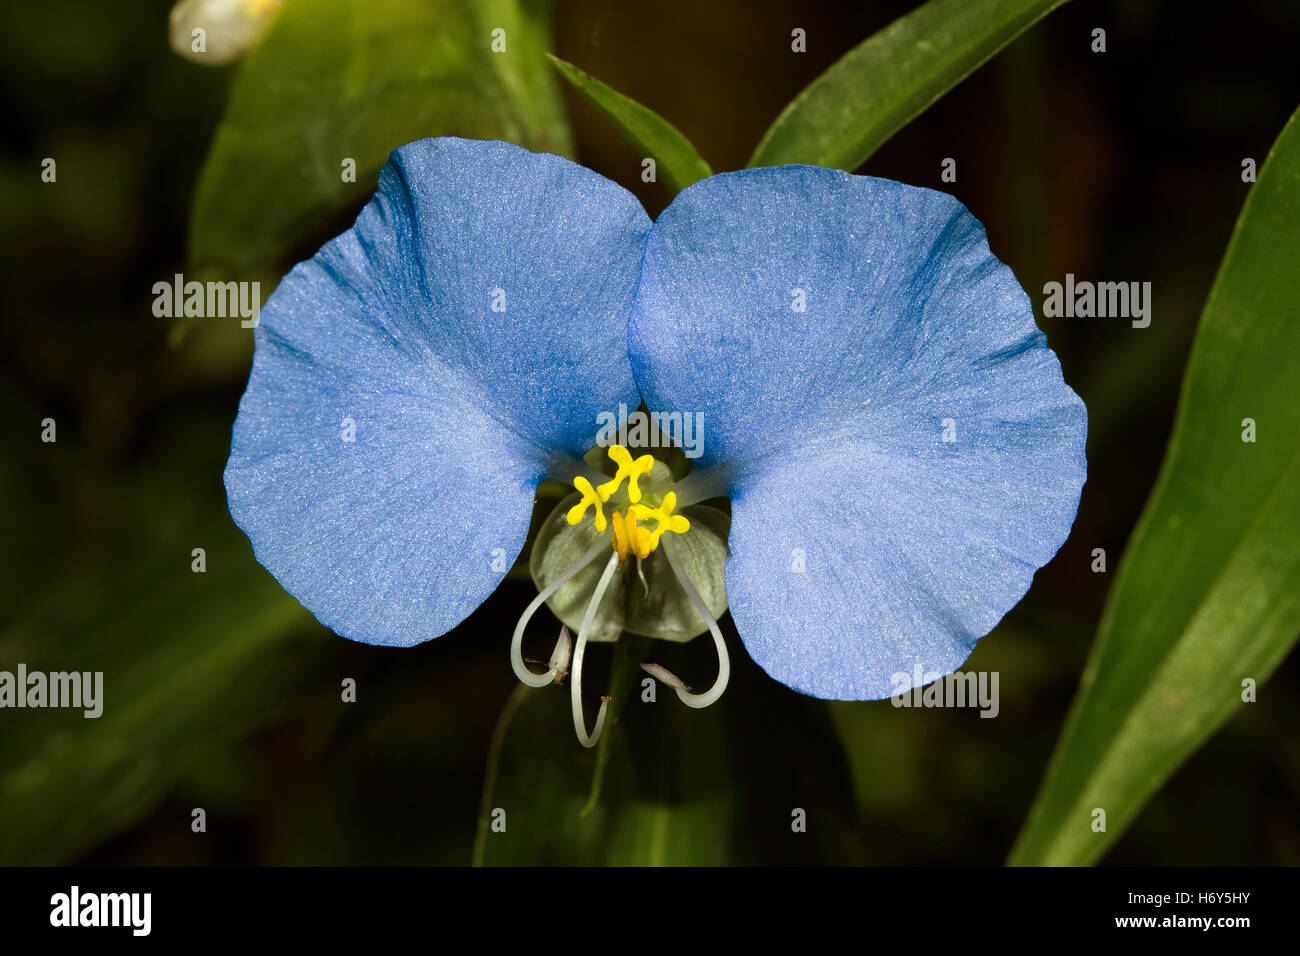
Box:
left=0, top=0, right=1300, bottom=864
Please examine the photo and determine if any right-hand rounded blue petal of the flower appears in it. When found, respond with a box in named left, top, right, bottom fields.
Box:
left=629, top=166, right=1087, bottom=700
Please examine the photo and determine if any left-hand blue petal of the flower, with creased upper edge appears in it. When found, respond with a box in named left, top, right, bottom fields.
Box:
left=225, top=139, right=650, bottom=646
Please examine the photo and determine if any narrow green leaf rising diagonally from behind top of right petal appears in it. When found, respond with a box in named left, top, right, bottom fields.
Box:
left=749, top=0, right=1065, bottom=170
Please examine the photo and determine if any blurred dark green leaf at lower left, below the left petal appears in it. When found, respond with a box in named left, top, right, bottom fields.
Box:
left=0, top=509, right=320, bottom=865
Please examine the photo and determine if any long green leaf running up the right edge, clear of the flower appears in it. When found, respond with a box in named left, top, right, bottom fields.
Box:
left=1010, top=104, right=1300, bottom=865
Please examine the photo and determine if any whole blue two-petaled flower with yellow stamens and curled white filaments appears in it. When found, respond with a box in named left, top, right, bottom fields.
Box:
left=226, top=139, right=1087, bottom=745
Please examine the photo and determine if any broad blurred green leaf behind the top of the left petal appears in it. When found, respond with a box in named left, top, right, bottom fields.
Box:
left=190, top=0, right=572, bottom=272
